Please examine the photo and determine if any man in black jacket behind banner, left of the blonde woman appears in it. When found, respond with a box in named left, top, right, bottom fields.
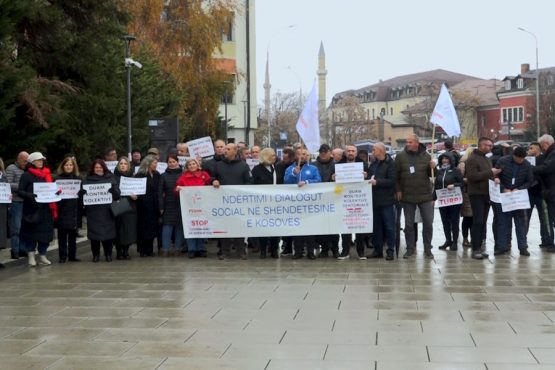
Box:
left=212, top=143, right=252, bottom=260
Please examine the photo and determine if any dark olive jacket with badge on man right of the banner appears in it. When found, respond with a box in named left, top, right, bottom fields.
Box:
left=395, top=143, right=433, bottom=204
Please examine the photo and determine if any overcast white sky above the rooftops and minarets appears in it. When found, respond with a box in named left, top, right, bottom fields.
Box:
left=256, top=0, right=555, bottom=104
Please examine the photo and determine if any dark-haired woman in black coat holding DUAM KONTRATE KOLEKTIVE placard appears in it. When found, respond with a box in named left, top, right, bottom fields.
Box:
left=81, top=159, right=120, bottom=262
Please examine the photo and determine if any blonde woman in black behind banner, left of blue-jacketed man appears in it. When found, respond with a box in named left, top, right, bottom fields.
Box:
left=252, top=148, right=279, bottom=258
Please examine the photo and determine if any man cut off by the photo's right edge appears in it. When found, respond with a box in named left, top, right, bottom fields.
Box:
left=534, top=134, right=555, bottom=253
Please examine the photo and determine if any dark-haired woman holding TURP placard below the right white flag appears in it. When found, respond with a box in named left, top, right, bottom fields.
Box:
left=434, top=152, right=463, bottom=251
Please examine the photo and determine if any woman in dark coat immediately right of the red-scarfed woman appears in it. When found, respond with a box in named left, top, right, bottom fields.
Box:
left=56, top=156, right=81, bottom=263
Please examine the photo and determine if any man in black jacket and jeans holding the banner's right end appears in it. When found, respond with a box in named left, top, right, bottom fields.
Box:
left=368, top=143, right=396, bottom=261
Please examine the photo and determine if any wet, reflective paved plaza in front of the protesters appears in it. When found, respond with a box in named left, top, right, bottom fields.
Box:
left=0, top=212, right=555, bottom=370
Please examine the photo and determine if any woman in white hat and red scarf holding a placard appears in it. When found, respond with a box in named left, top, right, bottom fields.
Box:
left=17, top=152, right=58, bottom=267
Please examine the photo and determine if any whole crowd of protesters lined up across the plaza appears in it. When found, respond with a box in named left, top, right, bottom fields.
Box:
left=0, top=135, right=555, bottom=266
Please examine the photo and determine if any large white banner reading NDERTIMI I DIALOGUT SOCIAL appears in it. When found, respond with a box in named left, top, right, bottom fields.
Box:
left=180, top=182, right=372, bottom=238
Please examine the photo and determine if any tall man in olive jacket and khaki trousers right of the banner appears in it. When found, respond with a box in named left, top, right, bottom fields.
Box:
left=395, top=134, right=435, bottom=259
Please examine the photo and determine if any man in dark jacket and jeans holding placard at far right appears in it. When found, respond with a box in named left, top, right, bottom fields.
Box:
left=494, top=147, right=534, bottom=256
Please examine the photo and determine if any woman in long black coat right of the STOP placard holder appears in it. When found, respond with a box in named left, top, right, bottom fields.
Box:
left=135, top=155, right=160, bottom=257
